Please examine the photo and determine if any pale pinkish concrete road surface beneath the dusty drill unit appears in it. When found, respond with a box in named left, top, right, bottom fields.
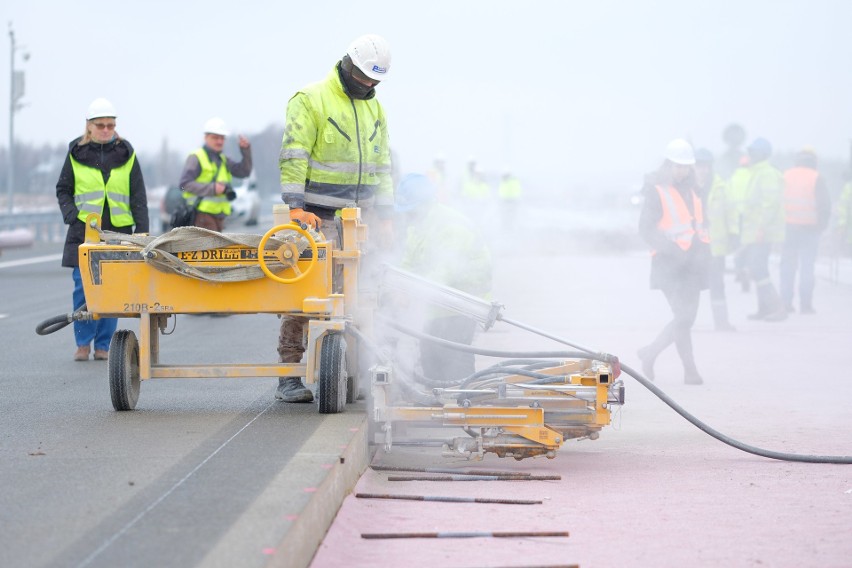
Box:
left=311, top=250, right=852, bottom=568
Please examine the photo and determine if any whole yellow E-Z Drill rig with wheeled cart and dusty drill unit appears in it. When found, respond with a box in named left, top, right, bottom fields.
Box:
left=36, top=208, right=624, bottom=459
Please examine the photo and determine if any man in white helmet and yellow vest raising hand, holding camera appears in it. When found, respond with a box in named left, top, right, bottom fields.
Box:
left=180, top=117, right=252, bottom=233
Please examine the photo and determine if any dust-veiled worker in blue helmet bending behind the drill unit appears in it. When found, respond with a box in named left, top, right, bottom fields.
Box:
left=388, top=174, right=491, bottom=380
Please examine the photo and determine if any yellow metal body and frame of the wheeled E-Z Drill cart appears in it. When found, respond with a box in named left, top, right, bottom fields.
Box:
left=79, top=208, right=367, bottom=383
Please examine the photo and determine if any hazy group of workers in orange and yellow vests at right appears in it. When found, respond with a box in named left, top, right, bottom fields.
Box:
left=638, top=134, right=852, bottom=385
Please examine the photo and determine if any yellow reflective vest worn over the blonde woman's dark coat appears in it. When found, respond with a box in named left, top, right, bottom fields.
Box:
left=69, top=152, right=136, bottom=227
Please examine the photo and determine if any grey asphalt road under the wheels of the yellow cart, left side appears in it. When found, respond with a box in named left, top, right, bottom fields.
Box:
left=0, top=244, right=366, bottom=567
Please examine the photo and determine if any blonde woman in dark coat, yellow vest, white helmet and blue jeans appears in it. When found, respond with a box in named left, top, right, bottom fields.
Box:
left=56, top=98, right=148, bottom=361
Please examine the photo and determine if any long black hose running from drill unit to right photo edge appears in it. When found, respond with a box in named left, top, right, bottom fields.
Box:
left=383, top=312, right=852, bottom=464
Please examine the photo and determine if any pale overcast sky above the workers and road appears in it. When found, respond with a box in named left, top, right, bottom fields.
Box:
left=0, top=0, right=852, bottom=191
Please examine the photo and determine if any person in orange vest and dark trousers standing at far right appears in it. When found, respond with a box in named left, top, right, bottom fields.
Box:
left=780, top=148, right=831, bottom=314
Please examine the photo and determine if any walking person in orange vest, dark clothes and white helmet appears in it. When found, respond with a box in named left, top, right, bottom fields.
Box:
left=639, top=138, right=710, bottom=385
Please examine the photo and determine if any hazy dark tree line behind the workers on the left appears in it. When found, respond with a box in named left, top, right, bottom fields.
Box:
left=0, top=124, right=284, bottom=202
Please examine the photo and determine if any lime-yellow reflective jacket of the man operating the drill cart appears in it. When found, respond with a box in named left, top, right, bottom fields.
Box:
left=279, top=67, right=393, bottom=214
